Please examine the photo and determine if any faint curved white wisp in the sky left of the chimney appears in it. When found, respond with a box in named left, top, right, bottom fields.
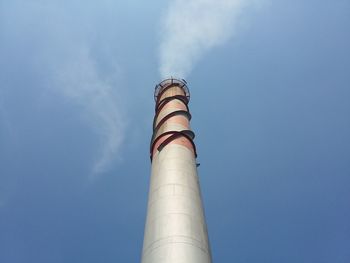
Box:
left=54, top=48, right=126, bottom=175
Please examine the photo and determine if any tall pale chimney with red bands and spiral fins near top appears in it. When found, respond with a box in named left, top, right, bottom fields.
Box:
left=142, top=78, right=211, bottom=263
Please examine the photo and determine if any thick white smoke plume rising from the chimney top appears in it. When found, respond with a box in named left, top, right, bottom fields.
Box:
left=160, top=0, right=260, bottom=78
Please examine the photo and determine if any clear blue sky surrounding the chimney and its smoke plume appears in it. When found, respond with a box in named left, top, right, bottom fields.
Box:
left=0, top=0, right=350, bottom=263
